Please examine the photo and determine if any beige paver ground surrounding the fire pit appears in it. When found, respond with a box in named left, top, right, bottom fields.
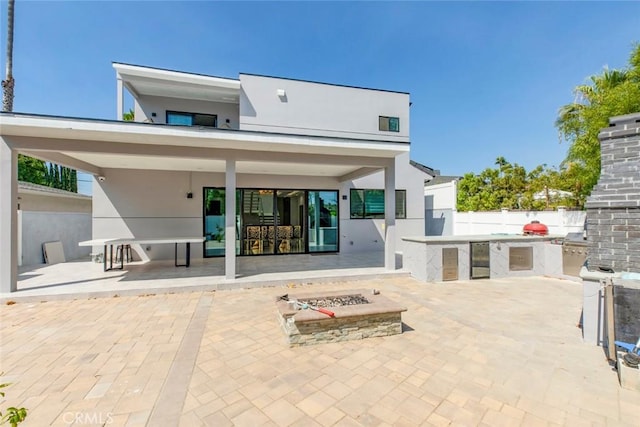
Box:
left=0, top=277, right=640, bottom=426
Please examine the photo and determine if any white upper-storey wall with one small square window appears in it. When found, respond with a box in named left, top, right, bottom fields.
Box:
left=240, top=74, right=409, bottom=142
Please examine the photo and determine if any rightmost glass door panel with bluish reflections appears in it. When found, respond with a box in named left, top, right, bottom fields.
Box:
left=307, top=191, right=338, bottom=252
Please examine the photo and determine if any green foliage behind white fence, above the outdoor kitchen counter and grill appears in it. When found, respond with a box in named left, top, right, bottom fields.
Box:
left=457, top=157, right=582, bottom=212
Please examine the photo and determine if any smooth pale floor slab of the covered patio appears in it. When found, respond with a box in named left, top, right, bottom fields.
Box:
left=5, top=252, right=409, bottom=302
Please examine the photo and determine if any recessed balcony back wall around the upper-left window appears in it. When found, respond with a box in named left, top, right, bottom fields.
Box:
left=134, top=96, right=240, bottom=129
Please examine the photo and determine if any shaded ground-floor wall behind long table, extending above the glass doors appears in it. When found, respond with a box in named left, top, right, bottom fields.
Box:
left=93, top=169, right=338, bottom=260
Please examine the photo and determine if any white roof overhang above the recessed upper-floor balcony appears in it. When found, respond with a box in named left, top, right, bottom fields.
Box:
left=113, top=62, right=240, bottom=104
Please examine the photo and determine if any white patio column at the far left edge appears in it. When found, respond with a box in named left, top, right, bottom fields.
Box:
left=0, top=137, right=18, bottom=294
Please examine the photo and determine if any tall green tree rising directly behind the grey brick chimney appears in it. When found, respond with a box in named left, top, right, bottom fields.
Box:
left=556, top=44, right=640, bottom=204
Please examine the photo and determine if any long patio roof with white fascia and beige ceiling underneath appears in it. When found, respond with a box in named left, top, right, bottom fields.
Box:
left=0, top=113, right=409, bottom=179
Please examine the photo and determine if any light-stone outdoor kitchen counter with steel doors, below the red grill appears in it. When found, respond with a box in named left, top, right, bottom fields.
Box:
left=402, top=234, right=565, bottom=282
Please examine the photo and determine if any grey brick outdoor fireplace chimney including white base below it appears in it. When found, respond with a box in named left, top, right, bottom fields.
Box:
left=580, top=114, right=640, bottom=345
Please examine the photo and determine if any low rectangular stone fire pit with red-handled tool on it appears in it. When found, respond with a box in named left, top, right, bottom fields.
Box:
left=276, top=289, right=407, bottom=347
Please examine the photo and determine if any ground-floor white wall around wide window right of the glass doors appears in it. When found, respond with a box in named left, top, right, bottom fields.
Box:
left=340, top=153, right=427, bottom=252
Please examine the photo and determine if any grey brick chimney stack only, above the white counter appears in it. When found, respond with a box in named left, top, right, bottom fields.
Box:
left=586, top=113, right=640, bottom=273
